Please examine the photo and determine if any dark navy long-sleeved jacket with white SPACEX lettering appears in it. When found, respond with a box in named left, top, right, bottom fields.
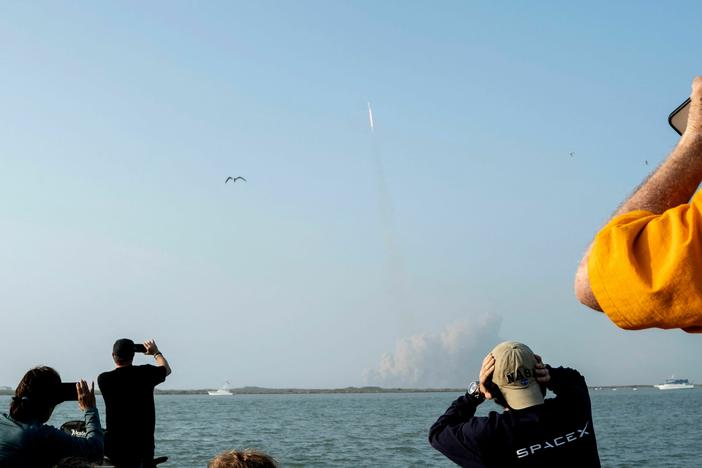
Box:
left=429, top=368, right=600, bottom=468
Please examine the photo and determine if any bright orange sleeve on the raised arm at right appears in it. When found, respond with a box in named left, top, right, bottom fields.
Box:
left=588, top=193, right=702, bottom=333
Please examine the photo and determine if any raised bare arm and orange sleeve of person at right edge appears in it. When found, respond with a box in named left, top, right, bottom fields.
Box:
left=575, top=77, right=702, bottom=332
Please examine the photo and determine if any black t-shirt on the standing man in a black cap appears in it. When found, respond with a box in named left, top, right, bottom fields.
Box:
left=98, top=364, right=166, bottom=459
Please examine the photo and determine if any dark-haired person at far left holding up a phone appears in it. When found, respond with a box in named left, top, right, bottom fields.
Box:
left=0, top=366, right=103, bottom=468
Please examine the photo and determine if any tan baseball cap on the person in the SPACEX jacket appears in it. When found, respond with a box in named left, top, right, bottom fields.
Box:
left=491, top=341, right=544, bottom=409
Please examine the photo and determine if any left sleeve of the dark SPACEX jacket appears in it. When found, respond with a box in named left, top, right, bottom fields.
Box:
left=429, top=396, right=485, bottom=468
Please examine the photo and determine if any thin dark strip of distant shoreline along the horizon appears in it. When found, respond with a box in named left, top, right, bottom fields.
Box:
left=0, top=384, right=702, bottom=395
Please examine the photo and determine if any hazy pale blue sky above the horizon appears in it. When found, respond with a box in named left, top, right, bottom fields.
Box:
left=0, top=0, right=702, bottom=388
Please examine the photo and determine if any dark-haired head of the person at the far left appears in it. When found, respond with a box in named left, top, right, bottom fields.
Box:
left=10, top=366, right=61, bottom=424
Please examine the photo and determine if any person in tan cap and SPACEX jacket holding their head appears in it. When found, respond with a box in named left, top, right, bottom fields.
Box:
left=429, top=341, right=600, bottom=468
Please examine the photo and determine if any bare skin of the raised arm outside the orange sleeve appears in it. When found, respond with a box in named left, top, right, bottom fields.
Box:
left=575, top=76, right=702, bottom=311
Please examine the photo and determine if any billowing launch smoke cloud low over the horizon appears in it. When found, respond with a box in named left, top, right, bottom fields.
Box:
left=365, top=315, right=502, bottom=388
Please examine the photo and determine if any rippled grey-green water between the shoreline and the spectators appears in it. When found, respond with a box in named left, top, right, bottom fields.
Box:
left=0, top=388, right=702, bottom=468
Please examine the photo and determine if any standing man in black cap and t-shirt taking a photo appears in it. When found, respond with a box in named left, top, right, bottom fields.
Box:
left=98, top=338, right=171, bottom=468
